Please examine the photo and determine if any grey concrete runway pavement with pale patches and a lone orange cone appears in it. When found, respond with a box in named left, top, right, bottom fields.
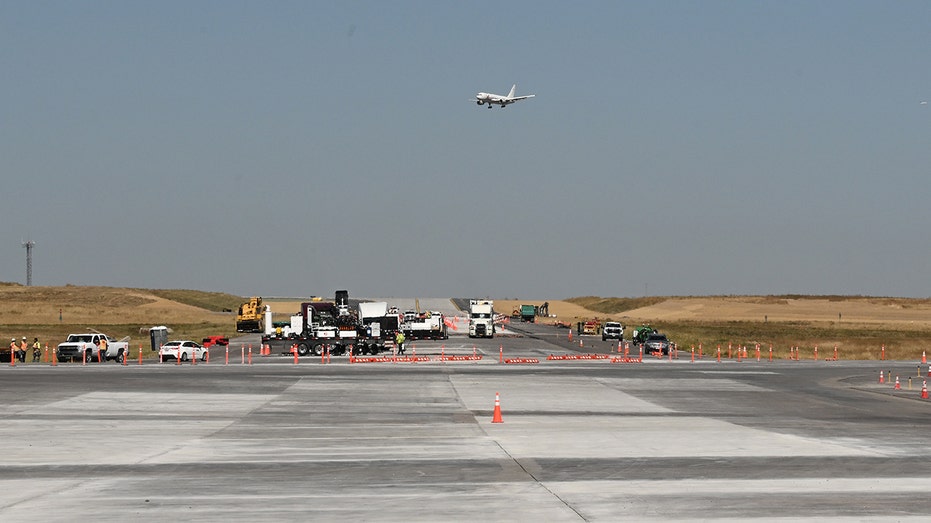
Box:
left=0, top=324, right=931, bottom=522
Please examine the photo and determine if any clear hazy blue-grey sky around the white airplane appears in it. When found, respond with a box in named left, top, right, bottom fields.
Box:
left=0, top=0, right=931, bottom=299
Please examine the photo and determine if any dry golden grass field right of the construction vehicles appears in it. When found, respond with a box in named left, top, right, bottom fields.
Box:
left=495, top=296, right=931, bottom=359
